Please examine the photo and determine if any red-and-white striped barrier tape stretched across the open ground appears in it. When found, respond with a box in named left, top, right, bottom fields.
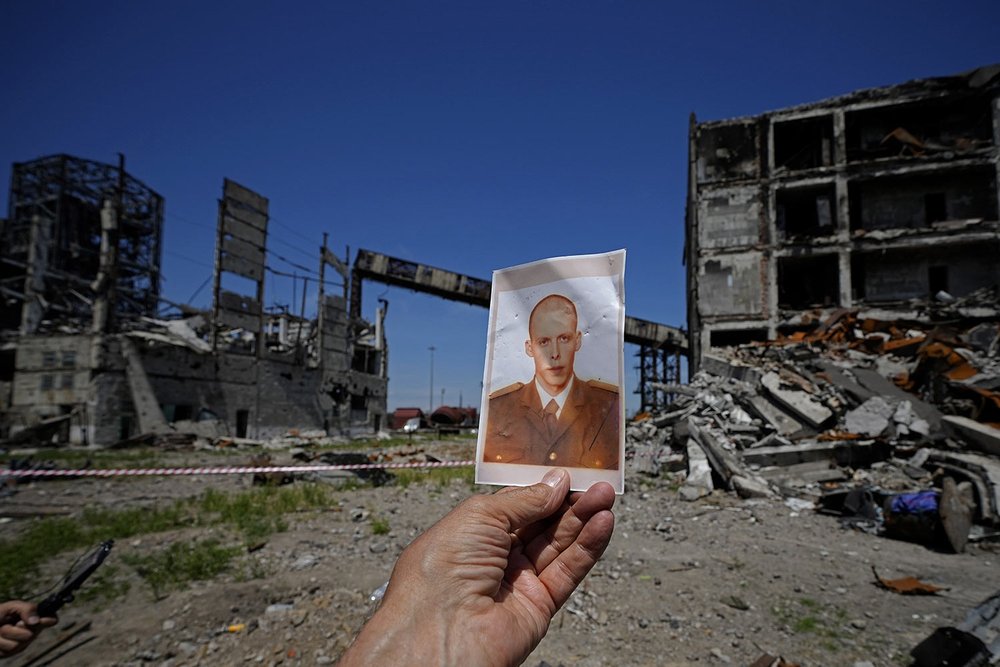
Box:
left=0, top=461, right=476, bottom=477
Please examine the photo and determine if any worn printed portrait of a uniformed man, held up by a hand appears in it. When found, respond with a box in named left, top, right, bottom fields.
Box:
left=476, top=250, right=625, bottom=493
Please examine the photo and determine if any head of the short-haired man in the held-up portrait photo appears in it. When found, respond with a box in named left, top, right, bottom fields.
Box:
left=524, top=303, right=581, bottom=396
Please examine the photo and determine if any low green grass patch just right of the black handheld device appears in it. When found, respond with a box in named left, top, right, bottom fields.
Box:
left=122, top=539, right=243, bottom=600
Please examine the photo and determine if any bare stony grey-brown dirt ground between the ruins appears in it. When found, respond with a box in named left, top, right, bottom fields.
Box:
left=0, top=442, right=1000, bottom=667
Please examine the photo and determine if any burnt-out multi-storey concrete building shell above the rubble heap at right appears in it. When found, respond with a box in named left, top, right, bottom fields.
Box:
left=685, top=65, right=1000, bottom=371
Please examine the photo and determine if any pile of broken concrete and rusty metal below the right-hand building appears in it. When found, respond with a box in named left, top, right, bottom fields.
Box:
left=626, top=306, right=1000, bottom=551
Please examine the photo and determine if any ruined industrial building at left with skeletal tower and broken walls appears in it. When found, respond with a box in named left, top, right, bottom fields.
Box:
left=0, top=155, right=386, bottom=444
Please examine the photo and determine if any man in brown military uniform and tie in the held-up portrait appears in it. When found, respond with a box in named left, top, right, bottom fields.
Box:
left=483, top=294, right=620, bottom=470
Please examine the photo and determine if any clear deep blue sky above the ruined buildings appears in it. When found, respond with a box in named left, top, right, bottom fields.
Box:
left=0, top=0, right=1000, bottom=412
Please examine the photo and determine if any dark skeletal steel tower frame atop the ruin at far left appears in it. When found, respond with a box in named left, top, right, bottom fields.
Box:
left=0, top=155, right=163, bottom=333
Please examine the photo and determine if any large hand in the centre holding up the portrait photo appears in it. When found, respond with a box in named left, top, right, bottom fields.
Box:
left=340, top=468, right=615, bottom=667
